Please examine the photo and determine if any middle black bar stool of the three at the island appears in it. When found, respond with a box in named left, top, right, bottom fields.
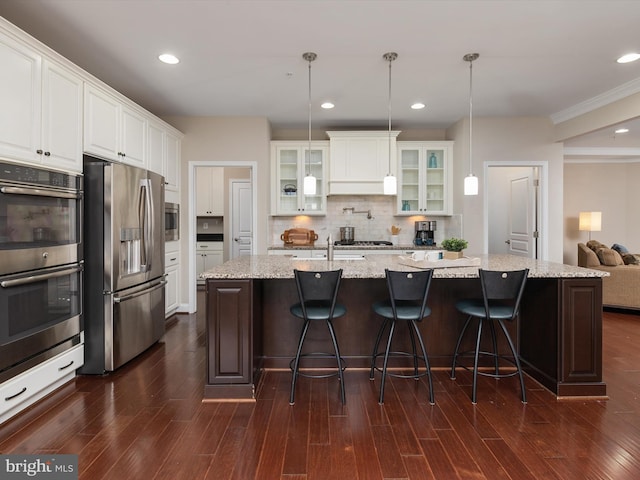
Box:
left=369, top=269, right=435, bottom=405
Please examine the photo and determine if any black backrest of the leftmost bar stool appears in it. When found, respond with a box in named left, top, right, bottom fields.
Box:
left=293, top=269, right=342, bottom=318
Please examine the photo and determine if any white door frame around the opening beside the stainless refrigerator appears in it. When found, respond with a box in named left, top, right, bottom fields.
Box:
left=183, top=161, right=258, bottom=313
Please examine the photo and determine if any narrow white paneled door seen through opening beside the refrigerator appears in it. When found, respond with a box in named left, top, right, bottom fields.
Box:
left=230, top=180, right=253, bottom=258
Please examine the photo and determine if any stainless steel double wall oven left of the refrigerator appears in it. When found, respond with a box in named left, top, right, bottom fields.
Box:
left=0, top=163, right=83, bottom=382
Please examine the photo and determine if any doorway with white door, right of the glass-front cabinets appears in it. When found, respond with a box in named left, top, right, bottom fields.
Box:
left=484, top=162, right=548, bottom=259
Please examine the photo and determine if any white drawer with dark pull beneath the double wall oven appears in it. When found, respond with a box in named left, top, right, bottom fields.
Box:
left=0, top=344, right=84, bottom=423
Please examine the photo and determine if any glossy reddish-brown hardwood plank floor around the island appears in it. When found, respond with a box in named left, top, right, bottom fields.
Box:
left=0, top=294, right=640, bottom=480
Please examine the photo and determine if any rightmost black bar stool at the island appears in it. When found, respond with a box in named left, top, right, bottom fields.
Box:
left=451, top=269, right=529, bottom=404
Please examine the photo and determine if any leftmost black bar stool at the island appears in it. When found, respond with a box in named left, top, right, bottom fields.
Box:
left=289, top=269, right=347, bottom=405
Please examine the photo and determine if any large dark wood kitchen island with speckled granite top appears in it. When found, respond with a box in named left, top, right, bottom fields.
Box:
left=202, top=255, right=606, bottom=400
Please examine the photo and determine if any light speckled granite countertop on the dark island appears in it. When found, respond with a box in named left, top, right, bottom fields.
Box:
left=201, top=254, right=608, bottom=279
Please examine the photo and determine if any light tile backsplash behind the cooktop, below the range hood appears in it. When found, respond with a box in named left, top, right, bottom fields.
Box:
left=269, top=195, right=462, bottom=246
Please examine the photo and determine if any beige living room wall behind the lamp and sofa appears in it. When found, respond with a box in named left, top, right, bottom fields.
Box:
left=563, top=161, right=640, bottom=265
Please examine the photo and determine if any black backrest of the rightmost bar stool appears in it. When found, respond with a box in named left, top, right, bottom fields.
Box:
left=478, top=268, right=529, bottom=320
